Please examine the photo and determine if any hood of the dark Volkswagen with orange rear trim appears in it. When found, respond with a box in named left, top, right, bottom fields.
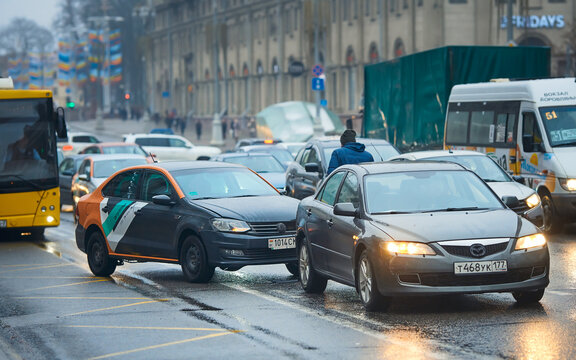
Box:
left=192, top=195, right=299, bottom=222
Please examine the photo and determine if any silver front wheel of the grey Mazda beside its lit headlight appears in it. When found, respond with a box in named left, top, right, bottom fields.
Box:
left=356, top=249, right=389, bottom=311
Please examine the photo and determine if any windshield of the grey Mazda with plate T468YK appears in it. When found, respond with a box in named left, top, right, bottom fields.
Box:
left=364, top=170, right=502, bottom=214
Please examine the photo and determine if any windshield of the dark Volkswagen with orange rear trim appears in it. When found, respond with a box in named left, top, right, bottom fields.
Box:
left=172, top=168, right=280, bottom=200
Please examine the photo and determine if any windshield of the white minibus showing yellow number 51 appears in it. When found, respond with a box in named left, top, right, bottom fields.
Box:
left=540, top=106, right=576, bottom=146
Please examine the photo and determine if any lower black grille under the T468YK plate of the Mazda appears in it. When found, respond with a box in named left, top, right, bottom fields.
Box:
left=419, top=267, right=532, bottom=286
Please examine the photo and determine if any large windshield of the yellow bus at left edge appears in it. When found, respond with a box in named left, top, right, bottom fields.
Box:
left=0, top=99, right=58, bottom=192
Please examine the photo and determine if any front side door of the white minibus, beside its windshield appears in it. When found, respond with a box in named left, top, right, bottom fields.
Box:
left=518, top=108, right=546, bottom=189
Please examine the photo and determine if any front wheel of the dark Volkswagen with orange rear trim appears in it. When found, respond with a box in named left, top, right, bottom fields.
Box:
left=180, top=236, right=214, bottom=283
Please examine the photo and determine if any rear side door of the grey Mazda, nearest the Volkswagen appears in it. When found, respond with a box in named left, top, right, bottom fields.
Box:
left=305, top=171, right=346, bottom=271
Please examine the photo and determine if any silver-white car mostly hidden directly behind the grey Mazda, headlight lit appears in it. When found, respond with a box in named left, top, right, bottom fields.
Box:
left=390, top=150, right=544, bottom=229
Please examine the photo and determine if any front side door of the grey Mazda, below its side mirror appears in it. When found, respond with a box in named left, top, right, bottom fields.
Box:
left=326, top=172, right=361, bottom=282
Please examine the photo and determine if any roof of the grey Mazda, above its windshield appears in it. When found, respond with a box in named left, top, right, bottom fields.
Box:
left=339, top=161, right=469, bottom=174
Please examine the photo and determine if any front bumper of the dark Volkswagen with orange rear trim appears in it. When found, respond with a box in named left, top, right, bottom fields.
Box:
left=200, top=231, right=298, bottom=269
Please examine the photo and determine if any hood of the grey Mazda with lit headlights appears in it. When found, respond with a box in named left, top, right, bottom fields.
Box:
left=373, top=209, right=521, bottom=243
